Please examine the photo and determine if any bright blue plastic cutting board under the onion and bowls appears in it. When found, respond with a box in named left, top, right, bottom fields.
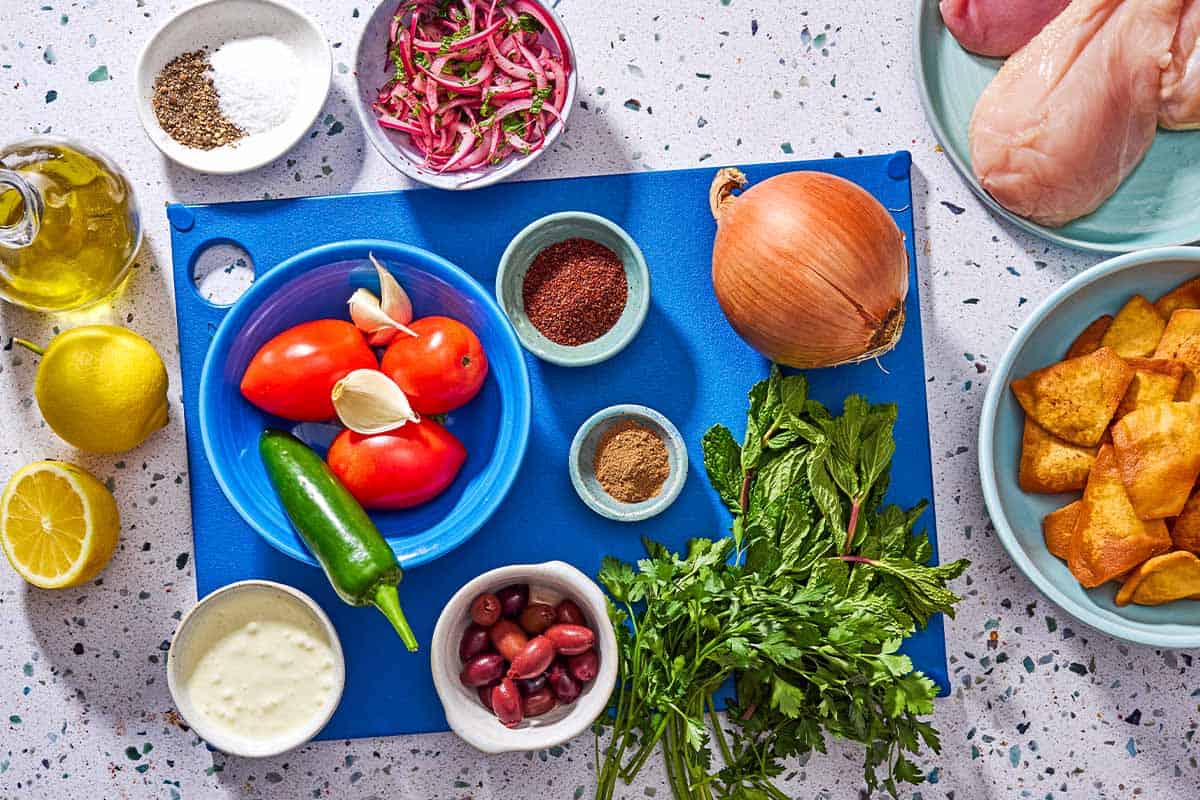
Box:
left=168, top=152, right=947, bottom=739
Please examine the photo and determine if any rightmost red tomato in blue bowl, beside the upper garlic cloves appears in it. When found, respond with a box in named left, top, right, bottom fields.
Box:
left=382, top=317, right=487, bottom=414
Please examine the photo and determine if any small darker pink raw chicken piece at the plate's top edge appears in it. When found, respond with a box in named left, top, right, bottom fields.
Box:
left=941, top=0, right=1070, bottom=56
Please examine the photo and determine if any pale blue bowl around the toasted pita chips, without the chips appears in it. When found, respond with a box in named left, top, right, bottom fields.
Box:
left=979, top=247, right=1200, bottom=648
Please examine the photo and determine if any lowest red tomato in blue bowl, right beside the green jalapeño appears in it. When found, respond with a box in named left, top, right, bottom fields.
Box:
left=326, top=419, right=467, bottom=509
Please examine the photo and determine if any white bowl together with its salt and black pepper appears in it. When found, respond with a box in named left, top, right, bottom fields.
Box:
left=137, top=0, right=334, bottom=175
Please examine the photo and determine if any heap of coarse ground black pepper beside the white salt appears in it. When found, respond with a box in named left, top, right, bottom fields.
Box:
left=152, top=50, right=246, bottom=150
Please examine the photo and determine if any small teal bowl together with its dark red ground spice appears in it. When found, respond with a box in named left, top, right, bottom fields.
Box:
left=496, top=211, right=650, bottom=367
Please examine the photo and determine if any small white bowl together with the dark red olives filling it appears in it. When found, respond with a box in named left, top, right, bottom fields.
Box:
left=431, top=561, right=617, bottom=753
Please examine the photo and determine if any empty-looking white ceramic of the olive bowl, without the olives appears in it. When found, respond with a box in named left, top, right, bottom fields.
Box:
left=430, top=561, right=617, bottom=753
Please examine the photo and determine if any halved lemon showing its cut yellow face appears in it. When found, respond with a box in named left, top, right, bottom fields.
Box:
left=0, top=461, right=121, bottom=589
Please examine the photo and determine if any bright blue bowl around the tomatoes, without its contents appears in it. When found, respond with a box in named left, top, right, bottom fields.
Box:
left=199, top=240, right=530, bottom=567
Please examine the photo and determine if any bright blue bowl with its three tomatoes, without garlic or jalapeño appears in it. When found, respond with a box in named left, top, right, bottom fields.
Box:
left=199, top=240, right=530, bottom=567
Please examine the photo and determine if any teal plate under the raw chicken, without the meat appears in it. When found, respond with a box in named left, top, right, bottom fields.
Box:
left=916, top=0, right=1200, bottom=253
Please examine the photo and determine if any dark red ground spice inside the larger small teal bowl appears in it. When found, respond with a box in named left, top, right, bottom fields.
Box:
left=521, top=239, right=629, bottom=347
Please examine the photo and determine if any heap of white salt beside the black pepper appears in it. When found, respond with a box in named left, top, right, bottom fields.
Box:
left=209, top=36, right=300, bottom=134
